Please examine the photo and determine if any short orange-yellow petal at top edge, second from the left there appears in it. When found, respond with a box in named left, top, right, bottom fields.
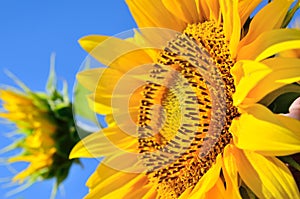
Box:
left=162, top=0, right=199, bottom=24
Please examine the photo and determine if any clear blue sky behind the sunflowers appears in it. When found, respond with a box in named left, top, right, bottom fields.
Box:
left=0, top=0, right=135, bottom=199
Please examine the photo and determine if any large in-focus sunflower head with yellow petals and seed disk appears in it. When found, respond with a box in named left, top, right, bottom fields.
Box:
left=70, top=0, right=300, bottom=198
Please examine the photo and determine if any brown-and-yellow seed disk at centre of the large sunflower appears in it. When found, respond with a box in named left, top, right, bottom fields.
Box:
left=138, top=22, right=238, bottom=198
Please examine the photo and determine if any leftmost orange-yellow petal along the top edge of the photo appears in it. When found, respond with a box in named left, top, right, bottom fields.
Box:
left=126, top=0, right=186, bottom=31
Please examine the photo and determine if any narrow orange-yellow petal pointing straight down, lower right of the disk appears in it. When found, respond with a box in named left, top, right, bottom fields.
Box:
left=222, top=145, right=242, bottom=199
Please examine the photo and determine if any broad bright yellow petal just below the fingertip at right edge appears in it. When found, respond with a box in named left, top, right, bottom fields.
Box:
left=230, top=104, right=300, bottom=156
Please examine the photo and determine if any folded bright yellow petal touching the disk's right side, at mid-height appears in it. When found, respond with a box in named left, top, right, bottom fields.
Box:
left=231, top=60, right=272, bottom=106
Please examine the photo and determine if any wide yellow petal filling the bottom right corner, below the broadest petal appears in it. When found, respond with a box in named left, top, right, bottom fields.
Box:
left=235, top=149, right=300, bottom=198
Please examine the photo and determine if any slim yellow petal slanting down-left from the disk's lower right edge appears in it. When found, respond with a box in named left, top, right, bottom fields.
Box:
left=190, top=155, right=222, bottom=198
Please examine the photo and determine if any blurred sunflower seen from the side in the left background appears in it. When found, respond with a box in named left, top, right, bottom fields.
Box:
left=0, top=59, right=79, bottom=196
